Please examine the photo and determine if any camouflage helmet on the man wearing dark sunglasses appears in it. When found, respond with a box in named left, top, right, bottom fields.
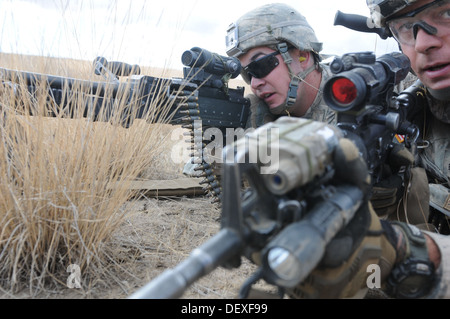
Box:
left=226, top=3, right=322, bottom=57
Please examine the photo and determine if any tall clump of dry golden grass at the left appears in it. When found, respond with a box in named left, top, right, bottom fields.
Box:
left=0, top=53, right=184, bottom=296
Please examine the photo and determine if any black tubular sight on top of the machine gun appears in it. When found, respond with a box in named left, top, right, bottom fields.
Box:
left=181, top=47, right=242, bottom=79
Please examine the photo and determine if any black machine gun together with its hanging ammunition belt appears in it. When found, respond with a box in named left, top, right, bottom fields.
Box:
left=0, top=47, right=250, bottom=202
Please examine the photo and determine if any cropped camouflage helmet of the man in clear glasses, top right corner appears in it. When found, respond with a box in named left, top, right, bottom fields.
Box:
left=366, top=0, right=417, bottom=28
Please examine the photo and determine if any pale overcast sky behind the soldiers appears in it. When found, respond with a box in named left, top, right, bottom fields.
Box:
left=0, top=0, right=398, bottom=69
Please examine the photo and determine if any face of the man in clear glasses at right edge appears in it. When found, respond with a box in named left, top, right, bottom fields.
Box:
left=399, top=0, right=450, bottom=90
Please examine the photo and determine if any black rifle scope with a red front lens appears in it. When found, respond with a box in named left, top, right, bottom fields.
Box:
left=324, top=52, right=411, bottom=112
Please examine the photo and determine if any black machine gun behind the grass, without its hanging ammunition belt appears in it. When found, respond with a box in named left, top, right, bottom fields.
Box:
left=0, top=47, right=249, bottom=130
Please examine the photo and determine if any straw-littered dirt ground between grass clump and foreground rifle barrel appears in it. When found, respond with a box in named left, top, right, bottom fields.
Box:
left=51, top=196, right=272, bottom=299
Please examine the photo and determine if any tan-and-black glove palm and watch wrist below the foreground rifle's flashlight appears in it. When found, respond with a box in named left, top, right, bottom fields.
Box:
left=288, top=210, right=440, bottom=299
